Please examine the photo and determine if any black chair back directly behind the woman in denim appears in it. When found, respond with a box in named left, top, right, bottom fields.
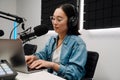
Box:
left=83, top=51, right=99, bottom=80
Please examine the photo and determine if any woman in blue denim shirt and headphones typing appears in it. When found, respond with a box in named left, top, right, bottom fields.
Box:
left=26, top=4, right=87, bottom=80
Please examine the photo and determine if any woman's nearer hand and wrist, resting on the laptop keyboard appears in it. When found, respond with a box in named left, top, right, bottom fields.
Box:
left=29, top=59, right=54, bottom=69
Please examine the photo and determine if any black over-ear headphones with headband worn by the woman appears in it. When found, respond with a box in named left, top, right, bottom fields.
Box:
left=68, top=5, right=78, bottom=27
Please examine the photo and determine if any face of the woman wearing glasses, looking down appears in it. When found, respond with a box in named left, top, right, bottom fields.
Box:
left=51, top=8, right=68, bottom=34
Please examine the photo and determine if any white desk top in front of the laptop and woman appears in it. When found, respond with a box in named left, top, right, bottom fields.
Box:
left=16, top=71, right=65, bottom=80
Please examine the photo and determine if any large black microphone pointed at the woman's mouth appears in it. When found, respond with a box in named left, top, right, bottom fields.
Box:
left=20, top=24, right=48, bottom=43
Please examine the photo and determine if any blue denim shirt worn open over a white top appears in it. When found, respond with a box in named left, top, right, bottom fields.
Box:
left=35, top=35, right=87, bottom=80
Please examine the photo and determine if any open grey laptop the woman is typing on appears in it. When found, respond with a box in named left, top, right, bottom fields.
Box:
left=0, top=39, right=43, bottom=73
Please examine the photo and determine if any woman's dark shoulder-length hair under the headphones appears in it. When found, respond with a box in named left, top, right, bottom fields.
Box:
left=57, top=3, right=80, bottom=35
